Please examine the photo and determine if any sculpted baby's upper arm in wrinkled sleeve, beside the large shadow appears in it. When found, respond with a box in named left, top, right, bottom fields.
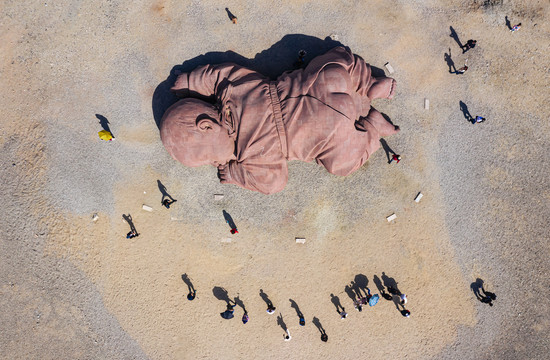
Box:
left=171, top=63, right=253, bottom=97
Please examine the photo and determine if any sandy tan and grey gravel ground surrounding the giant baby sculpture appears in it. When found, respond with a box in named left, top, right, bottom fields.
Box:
left=0, top=0, right=550, bottom=359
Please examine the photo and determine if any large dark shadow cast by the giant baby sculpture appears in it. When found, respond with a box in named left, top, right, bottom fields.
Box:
left=152, top=34, right=392, bottom=128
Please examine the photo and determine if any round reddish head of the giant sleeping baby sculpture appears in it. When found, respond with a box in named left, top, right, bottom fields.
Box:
left=160, top=98, right=235, bottom=167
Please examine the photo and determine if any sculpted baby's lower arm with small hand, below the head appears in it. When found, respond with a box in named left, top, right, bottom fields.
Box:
left=218, top=158, right=288, bottom=195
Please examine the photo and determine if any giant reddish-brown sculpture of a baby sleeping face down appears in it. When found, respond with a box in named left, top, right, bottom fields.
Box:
left=160, top=47, right=399, bottom=194
